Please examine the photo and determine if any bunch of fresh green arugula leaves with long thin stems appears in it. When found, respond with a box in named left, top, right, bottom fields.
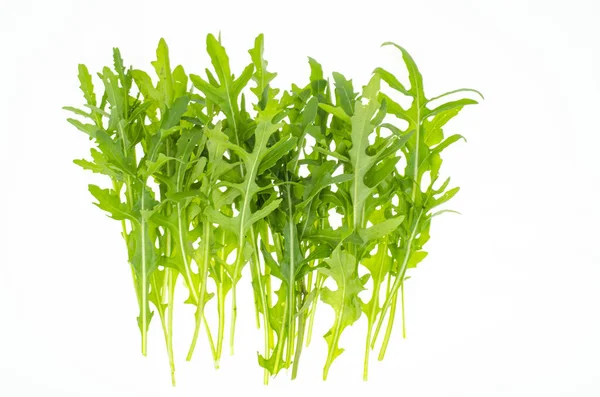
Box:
left=64, top=34, right=481, bottom=384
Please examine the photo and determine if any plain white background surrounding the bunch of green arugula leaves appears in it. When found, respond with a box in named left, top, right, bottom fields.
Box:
left=0, top=0, right=600, bottom=397
